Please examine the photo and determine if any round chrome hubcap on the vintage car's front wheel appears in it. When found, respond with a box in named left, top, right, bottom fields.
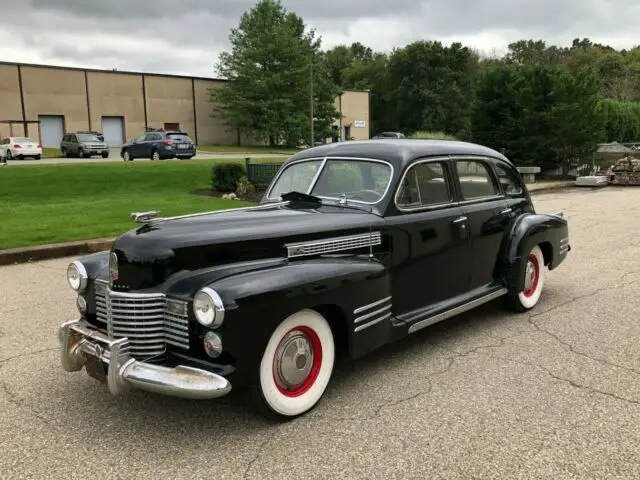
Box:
left=274, top=331, right=313, bottom=389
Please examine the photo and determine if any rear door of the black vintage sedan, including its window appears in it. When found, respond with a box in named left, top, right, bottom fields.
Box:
left=452, top=157, right=511, bottom=290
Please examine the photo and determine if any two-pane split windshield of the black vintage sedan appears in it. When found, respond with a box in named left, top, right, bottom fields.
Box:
left=268, top=159, right=391, bottom=203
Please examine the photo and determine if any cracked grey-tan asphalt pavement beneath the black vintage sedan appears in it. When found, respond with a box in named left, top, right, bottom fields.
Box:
left=0, top=187, right=640, bottom=479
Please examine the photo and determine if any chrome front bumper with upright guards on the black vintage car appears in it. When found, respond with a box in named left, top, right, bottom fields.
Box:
left=60, top=320, right=231, bottom=399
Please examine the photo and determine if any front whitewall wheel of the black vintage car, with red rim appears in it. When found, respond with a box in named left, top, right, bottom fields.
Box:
left=253, top=310, right=335, bottom=420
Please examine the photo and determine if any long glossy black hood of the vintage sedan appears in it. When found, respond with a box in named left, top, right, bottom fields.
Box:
left=112, top=205, right=383, bottom=290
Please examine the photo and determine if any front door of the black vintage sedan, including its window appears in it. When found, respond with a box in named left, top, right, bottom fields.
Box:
left=387, top=158, right=469, bottom=315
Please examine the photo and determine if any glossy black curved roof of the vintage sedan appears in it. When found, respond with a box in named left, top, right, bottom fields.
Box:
left=286, top=138, right=512, bottom=168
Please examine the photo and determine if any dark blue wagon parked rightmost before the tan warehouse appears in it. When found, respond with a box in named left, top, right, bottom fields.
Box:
left=120, top=130, right=196, bottom=162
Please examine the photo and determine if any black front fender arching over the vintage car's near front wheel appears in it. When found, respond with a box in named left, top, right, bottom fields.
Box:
left=203, top=256, right=390, bottom=382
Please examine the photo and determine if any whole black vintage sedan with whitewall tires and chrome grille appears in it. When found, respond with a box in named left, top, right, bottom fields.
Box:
left=60, top=139, right=570, bottom=419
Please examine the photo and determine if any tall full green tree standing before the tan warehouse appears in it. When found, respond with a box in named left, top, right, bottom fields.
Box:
left=210, top=0, right=338, bottom=146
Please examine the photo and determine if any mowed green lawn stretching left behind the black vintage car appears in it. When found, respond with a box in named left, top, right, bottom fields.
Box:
left=0, top=158, right=284, bottom=250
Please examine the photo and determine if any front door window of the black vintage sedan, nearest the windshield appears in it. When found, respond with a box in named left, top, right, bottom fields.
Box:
left=396, top=162, right=453, bottom=209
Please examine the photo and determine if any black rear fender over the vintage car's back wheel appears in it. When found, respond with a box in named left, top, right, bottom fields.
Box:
left=502, top=213, right=570, bottom=291
